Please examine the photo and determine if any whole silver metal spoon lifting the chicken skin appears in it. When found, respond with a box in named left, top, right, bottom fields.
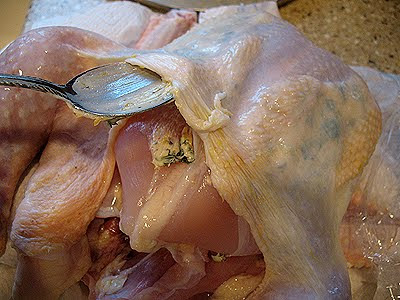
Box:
left=0, top=62, right=173, bottom=124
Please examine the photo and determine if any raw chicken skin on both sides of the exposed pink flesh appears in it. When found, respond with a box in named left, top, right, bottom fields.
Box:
left=0, top=2, right=381, bottom=299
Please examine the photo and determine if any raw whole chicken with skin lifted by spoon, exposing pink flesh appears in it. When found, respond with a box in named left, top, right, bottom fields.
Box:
left=0, top=0, right=381, bottom=299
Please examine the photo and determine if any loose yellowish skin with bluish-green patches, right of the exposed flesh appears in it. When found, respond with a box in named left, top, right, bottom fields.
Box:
left=129, top=11, right=381, bottom=299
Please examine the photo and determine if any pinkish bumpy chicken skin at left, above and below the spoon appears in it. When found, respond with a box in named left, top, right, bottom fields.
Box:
left=0, top=27, right=130, bottom=299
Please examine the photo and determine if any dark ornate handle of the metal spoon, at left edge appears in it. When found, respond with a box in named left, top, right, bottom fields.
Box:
left=0, top=73, right=68, bottom=99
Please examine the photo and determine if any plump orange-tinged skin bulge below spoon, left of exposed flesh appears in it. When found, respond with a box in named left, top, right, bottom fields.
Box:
left=10, top=105, right=115, bottom=257
